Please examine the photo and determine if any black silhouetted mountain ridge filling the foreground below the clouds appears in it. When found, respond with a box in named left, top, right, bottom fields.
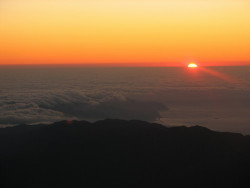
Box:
left=0, top=120, right=250, bottom=188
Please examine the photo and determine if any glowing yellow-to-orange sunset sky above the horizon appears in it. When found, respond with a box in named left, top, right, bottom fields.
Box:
left=0, top=0, right=250, bottom=66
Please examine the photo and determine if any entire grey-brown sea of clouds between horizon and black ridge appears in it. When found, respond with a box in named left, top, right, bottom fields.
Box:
left=0, top=68, right=250, bottom=133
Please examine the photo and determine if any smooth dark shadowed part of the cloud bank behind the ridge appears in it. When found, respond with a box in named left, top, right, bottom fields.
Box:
left=39, top=98, right=167, bottom=121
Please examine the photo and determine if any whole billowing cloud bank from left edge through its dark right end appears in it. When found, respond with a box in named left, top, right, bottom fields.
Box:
left=0, top=92, right=167, bottom=125
